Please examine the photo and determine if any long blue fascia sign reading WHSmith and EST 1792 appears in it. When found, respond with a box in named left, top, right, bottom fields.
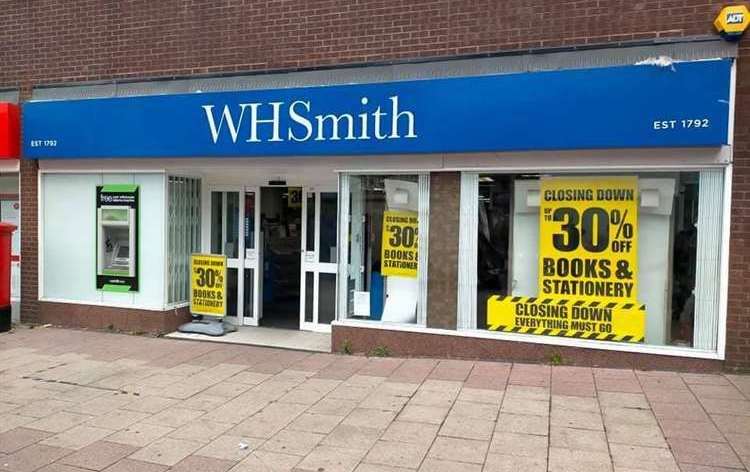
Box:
left=23, top=59, right=732, bottom=159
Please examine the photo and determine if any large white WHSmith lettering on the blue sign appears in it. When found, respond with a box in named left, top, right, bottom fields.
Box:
left=201, top=95, right=417, bottom=144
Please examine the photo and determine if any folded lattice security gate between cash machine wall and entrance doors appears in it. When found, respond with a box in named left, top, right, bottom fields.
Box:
left=167, top=176, right=201, bottom=304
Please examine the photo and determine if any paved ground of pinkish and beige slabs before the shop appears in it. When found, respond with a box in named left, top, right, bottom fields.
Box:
left=0, top=328, right=750, bottom=472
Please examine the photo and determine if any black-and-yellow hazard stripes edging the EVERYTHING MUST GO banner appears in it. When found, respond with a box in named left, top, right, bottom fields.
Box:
left=487, top=295, right=646, bottom=343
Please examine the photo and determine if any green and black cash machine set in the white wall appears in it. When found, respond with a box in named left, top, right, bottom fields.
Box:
left=96, top=184, right=138, bottom=292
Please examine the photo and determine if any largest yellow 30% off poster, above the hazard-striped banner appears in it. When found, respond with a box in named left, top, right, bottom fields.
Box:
left=539, top=177, right=638, bottom=302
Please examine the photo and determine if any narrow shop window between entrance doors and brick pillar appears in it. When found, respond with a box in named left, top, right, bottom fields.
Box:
left=340, top=175, right=429, bottom=324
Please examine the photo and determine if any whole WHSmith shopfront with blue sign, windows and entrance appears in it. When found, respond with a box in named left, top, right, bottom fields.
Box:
left=23, top=42, right=736, bottom=366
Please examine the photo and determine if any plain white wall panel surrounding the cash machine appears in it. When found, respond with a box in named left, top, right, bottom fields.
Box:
left=40, top=173, right=166, bottom=310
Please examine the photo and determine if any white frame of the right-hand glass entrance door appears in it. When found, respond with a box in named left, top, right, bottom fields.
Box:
left=300, top=186, right=338, bottom=333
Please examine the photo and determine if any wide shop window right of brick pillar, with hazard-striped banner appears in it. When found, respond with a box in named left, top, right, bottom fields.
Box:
left=459, top=169, right=724, bottom=351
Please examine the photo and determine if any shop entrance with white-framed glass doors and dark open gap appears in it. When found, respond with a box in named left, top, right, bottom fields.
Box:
left=210, top=186, right=338, bottom=332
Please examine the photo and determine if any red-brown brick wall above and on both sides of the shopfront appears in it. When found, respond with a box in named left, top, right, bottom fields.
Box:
left=0, top=0, right=750, bottom=367
